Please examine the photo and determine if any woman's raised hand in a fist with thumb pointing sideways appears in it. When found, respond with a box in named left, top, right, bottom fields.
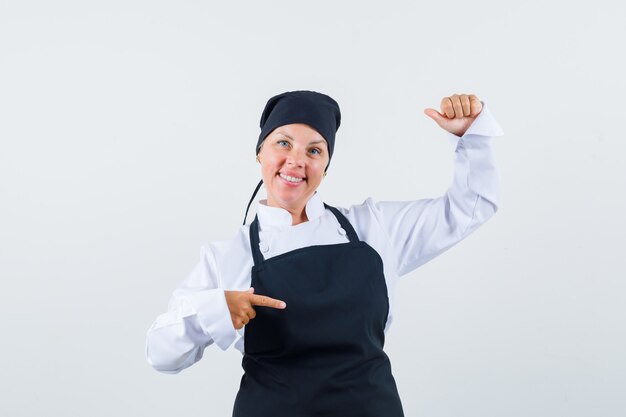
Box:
left=424, top=94, right=483, bottom=136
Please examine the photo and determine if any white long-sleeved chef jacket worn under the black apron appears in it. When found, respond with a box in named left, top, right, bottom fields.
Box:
left=145, top=102, right=503, bottom=373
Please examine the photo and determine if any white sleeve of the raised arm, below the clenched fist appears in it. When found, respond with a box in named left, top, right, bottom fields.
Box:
left=367, top=102, right=503, bottom=276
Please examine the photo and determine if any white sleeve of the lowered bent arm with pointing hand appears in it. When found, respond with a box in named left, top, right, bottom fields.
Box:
left=145, top=242, right=237, bottom=373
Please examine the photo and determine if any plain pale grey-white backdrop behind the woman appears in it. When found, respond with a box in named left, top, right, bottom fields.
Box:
left=0, top=0, right=626, bottom=417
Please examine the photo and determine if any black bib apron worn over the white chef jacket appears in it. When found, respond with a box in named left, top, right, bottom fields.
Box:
left=233, top=204, right=404, bottom=417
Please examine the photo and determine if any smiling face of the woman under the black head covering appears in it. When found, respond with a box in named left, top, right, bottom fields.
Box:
left=258, top=123, right=330, bottom=216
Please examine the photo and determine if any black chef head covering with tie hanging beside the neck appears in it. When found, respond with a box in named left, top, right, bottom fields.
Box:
left=243, top=90, right=341, bottom=224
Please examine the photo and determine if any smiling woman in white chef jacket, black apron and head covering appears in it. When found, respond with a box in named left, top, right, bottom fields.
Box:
left=146, top=91, right=502, bottom=417
